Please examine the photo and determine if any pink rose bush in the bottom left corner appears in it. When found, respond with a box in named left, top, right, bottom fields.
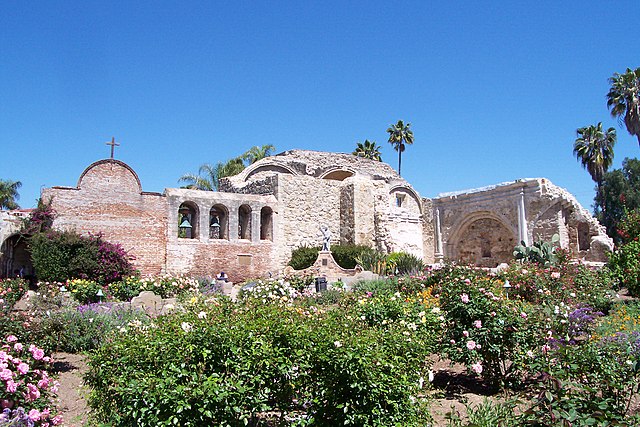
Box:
left=0, top=335, right=62, bottom=426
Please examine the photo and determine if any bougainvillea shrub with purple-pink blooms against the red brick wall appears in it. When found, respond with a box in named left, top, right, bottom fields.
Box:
left=29, top=231, right=133, bottom=284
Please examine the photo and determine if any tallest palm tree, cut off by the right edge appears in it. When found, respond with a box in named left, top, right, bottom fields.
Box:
left=607, top=68, right=640, bottom=144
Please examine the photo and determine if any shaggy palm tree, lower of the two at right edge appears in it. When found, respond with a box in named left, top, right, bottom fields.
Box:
left=573, top=122, right=616, bottom=194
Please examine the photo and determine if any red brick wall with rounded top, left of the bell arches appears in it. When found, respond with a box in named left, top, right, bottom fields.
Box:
left=41, top=160, right=167, bottom=274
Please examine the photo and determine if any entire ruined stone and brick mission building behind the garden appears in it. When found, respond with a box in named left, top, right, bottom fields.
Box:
left=0, top=150, right=612, bottom=282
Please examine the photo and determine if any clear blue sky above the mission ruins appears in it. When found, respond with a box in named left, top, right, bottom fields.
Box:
left=0, top=0, right=640, bottom=208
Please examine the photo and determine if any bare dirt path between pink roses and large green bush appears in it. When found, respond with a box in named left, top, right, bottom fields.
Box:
left=53, top=353, right=88, bottom=427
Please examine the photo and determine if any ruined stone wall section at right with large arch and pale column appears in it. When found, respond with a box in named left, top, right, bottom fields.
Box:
left=433, top=179, right=613, bottom=267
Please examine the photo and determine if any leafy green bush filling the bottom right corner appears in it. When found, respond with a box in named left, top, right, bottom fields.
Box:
left=522, top=333, right=640, bottom=426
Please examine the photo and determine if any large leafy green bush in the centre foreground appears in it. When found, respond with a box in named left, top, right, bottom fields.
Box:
left=86, top=300, right=432, bottom=427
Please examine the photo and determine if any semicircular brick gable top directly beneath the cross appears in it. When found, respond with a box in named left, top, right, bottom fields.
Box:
left=77, top=159, right=142, bottom=194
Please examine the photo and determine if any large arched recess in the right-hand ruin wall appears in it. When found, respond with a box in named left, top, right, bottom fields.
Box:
left=448, top=212, right=518, bottom=267
